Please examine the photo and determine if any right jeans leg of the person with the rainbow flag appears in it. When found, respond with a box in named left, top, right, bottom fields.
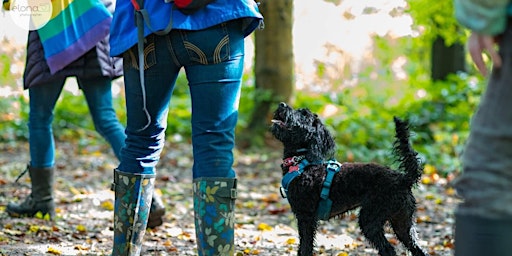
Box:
left=77, top=77, right=126, bottom=159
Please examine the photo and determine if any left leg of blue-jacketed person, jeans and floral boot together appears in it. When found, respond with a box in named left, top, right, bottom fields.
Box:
left=112, top=35, right=180, bottom=255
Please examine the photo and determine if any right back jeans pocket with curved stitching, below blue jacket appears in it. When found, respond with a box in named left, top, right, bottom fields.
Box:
left=182, top=23, right=230, bottom=65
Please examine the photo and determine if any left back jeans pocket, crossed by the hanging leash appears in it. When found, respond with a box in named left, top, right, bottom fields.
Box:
left=123, top=35, right=156, bottom=70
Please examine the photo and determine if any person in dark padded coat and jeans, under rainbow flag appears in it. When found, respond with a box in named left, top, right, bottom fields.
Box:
left=6, top=1, right=165, bottom=227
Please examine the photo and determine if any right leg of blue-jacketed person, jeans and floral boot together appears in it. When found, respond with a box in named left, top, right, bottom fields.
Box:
left=184, top=20, right=244, bottom=255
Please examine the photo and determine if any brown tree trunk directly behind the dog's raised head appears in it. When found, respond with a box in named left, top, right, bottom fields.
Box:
left=245, top=0, right=294, bottom=147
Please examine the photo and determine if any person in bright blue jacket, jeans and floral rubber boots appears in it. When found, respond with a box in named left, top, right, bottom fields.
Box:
left=110, top=0, right=263, bottom=255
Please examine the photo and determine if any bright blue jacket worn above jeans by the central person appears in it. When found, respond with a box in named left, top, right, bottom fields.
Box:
left=110, top=0, right=263, bottom=56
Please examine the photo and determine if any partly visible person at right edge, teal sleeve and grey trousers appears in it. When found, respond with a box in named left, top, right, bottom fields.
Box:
left=455, top=0, right=512, bottom=256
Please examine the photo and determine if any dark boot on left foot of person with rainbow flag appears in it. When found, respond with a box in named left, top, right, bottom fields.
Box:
left=5, top=166, right=55, bottom=219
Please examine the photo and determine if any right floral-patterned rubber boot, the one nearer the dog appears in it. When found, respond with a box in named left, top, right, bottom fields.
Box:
left=193, top=177, right=237, bottom=256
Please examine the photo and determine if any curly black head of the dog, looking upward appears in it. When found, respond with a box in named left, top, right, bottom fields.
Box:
left=271, top=103, right=335, bottom=162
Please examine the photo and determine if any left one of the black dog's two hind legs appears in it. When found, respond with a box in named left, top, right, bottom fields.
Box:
left=359, top=206, right=396, bottom=256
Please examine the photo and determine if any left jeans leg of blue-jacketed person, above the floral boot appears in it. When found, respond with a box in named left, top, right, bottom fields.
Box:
left=118, top=35, right=180, bottom=173
